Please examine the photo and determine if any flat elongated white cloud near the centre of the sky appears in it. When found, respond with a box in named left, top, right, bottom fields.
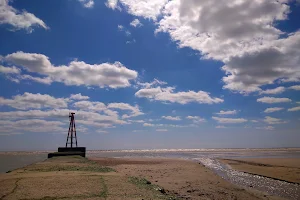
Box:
left=135, top=79, right=224, bottom=104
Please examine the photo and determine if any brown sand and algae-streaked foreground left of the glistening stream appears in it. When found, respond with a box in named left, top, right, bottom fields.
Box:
left=0, top=157, right=281, bottom=200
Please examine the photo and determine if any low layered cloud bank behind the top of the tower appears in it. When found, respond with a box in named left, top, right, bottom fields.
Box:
left=0, top=92, right=145, bottom=135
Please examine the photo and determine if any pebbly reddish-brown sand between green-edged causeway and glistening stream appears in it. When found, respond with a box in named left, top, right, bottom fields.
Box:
left=92, top=158, right=282, bottom=200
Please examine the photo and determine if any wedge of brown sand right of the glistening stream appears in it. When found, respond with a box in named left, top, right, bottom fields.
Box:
left=221, top=158, right=300, bottom=184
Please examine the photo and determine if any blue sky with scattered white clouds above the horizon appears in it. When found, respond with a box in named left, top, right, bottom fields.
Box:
left=0, top=0, right=300, bottom=151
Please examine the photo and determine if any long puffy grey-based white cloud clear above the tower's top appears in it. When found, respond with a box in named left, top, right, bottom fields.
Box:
left=5, top=52, right=138, bottom=88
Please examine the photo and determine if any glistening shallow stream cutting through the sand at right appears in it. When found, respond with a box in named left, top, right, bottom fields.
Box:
left=193, top=158, right=300, bottom=199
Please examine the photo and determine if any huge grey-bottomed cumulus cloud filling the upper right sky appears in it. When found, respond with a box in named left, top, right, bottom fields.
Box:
left=109, top=0, right=300, bottom=93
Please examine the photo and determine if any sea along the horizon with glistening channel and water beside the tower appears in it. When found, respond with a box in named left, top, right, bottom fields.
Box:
left=0, top=148, right=300, bottom=199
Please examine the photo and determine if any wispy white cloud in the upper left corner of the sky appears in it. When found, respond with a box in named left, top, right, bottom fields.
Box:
left=0, top=0, right=49, bottom=33
